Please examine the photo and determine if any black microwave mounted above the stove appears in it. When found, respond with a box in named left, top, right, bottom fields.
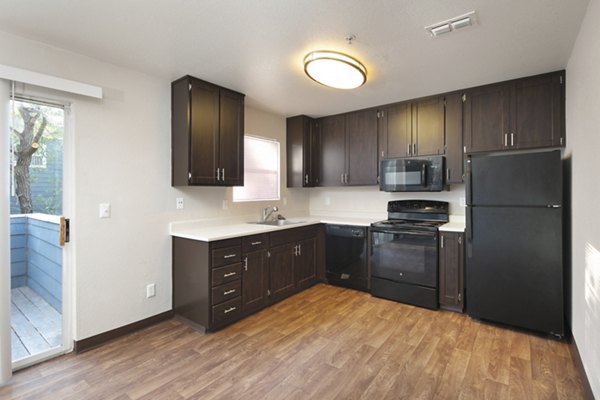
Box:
left=379, top=156, right=444, bottom=192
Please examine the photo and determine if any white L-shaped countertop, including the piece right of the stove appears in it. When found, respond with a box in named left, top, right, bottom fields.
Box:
left=169, top=215, right=465, bottom=242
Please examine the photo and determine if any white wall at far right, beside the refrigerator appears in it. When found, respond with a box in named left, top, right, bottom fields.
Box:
left=566, top=0, right=600, bottom=398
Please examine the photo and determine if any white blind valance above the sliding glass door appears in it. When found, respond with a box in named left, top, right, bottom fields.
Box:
left=0, top=64, right=103, bottom=99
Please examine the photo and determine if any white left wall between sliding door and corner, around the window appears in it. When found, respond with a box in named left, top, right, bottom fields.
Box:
left=0, top=28, right=300, bottom=340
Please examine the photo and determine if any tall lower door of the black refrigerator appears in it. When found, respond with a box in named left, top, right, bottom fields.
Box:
left=466, top=207, right=564, bottom=335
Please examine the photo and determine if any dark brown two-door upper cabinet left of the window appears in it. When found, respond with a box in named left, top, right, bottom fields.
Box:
left=171, top=76, right=244, bottom=186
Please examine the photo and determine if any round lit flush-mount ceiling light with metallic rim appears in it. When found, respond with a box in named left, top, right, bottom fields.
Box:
left=304, top=47, right=367, bottom=89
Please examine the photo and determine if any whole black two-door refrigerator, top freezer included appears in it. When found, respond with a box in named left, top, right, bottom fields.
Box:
left=466, top=150, right=564, bottom=337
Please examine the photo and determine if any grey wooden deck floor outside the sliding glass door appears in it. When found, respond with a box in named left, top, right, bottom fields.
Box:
left=10, top=286, right=62, bottom=362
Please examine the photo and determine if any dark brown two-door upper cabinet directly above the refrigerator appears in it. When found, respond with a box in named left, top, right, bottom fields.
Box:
left=464, top=71, right=565, bottom=153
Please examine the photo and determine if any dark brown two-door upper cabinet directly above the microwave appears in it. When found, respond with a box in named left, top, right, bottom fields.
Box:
left=378, top=96, right=444, bottom=158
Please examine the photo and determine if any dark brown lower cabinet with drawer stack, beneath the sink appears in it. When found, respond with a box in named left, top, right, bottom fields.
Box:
left=173, top=225, right=325, bottom=331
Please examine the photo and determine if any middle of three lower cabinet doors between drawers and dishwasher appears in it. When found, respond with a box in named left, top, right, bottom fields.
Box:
left=269, top=244, right=296, bottom=301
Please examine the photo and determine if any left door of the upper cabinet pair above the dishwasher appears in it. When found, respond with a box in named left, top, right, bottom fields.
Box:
left=319, top=115, right=346, bottom=186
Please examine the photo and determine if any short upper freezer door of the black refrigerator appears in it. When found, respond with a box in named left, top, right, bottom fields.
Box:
left=467, top=150, right=562, bottom=206
